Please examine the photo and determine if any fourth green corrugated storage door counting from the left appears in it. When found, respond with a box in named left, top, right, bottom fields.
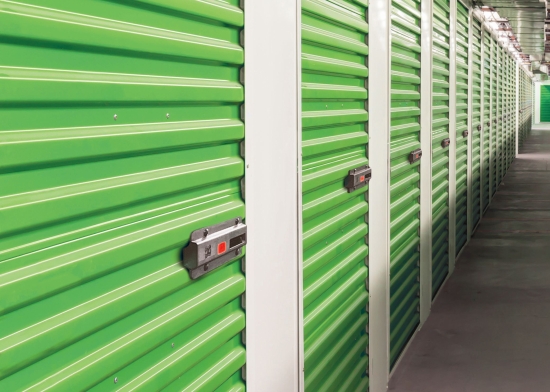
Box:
left=432, top=0, right=450, bottom=297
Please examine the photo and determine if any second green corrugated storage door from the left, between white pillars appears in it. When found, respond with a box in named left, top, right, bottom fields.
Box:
left=302, top=0, right=369, bottom=391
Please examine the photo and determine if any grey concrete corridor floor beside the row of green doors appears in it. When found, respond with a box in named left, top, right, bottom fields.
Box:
left=389, top=127, right=550, bottom=392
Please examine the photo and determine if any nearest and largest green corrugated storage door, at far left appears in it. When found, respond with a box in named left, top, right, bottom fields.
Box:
left=0, top=0, right=245, bottom=391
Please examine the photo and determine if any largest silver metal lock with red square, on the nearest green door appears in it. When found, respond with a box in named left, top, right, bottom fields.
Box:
left=183, top=217, right=246, bottom=279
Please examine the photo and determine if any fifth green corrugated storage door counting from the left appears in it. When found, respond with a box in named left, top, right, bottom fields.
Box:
left=456, top=3, right=469, bottom=254
